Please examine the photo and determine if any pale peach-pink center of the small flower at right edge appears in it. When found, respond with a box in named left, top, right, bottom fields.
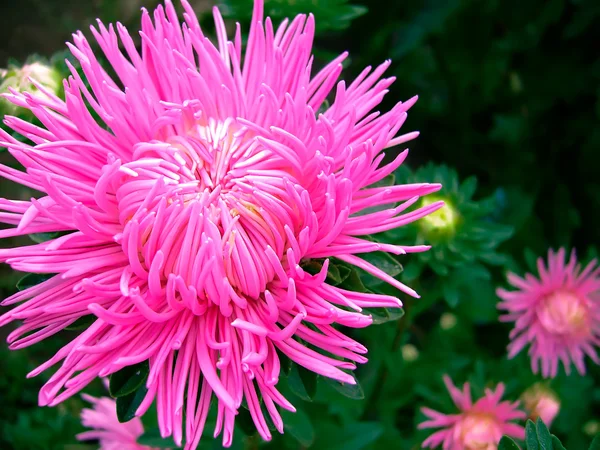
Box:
left=537, top=291, right=590, bottom=336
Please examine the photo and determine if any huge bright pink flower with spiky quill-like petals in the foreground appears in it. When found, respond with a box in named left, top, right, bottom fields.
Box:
left=0, top=0, right=441, bottom=449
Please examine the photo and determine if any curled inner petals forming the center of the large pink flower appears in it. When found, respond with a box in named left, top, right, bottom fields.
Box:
left=98, top=104, right=312, bottom=314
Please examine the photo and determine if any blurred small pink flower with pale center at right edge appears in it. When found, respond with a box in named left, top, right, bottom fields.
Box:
left=497, top=249, right=600, bottom=377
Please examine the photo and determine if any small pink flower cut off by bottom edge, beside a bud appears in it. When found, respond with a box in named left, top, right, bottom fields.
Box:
left=418, top=375, right=525, bottom=450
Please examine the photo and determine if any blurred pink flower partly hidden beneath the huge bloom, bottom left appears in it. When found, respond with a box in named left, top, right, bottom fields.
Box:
left=77, top=394, right=153, bottom=450
